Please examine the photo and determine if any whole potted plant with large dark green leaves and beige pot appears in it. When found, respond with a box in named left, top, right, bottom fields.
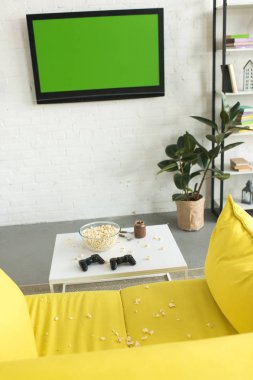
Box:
left=157, top=93, right=245, bottom=231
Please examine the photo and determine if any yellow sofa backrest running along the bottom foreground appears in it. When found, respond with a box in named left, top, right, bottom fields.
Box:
left=0, top=333, right=253, bottom=380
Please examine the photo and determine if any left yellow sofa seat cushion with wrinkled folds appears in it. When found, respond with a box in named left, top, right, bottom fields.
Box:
left=26, top=291, right=127, bottom=356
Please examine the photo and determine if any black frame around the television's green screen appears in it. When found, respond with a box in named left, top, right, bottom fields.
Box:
left=26, top=8, right=165, bottom=104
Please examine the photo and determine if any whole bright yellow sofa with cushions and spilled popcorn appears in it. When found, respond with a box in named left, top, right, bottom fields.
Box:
left=0, top=197, right=253, bottom=380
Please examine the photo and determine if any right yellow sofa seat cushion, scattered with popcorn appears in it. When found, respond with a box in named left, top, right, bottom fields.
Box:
left=121, top=279, right=236, bottom=346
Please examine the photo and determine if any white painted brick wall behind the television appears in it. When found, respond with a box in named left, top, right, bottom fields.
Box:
left=0, top=0, right=212, bottom=225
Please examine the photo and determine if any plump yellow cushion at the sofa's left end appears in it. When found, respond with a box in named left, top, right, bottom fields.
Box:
left=0, top=269, right=37, bottom=361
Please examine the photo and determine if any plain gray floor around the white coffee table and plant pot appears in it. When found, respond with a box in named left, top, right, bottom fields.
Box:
left=0, top=210, right=216, bottom=285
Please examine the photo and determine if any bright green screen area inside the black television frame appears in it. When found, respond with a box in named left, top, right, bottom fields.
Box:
left=33, top=14, right=159, bottom=93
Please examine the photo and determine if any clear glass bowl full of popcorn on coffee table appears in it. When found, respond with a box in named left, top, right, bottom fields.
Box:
left=79, top=221, right=120, bottom=252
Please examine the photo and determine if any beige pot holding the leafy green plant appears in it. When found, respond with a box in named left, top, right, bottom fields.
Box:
left=176, top=197, right=205, bottom=231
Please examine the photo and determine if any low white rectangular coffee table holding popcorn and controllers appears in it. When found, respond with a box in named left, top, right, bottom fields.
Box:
left=49, top=224, right=188, bottom=292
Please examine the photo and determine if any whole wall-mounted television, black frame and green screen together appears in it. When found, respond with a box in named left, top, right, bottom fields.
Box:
left=26, top=8, right=164, bottom=103
